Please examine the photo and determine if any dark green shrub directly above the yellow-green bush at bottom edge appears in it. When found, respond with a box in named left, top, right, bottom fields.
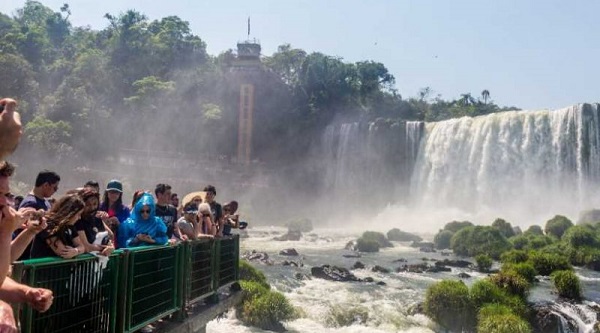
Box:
left=469, top=279, right=527, bottom=317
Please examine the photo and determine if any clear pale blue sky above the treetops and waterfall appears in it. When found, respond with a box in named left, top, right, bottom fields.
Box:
left=0, top=0, right=600, bottom=109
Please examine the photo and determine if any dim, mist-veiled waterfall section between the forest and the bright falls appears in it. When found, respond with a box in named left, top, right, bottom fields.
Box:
left=322, top=122, right=424, bottom=207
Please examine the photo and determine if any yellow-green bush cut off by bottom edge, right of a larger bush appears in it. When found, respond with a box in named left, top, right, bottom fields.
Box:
left=477, top=304, right=532, bottom=333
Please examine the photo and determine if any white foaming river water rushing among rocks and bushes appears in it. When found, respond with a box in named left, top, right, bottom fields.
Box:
left=207, top=227, right=600, bottom=333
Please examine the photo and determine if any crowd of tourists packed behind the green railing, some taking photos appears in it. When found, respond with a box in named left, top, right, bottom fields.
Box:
left=0, top=98, right=246, bottom=332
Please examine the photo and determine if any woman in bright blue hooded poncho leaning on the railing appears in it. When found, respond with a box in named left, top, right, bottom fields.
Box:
left=119, top=193, right=169, bottom=247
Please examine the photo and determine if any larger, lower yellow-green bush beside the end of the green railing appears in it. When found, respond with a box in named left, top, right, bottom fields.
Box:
left=238, top=281, right=297, bottom=330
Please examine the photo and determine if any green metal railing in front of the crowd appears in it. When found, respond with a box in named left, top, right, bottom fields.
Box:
left=13, top=236, right=239, bottom=333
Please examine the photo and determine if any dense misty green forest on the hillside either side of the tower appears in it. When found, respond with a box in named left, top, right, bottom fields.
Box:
left=0, top=1, right=510, bottom=166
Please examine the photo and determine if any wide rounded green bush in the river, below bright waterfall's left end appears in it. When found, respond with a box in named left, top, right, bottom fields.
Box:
left=450, top=226, right=512, bottom=259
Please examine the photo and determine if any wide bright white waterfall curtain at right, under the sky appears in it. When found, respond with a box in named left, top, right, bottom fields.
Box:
left=411, top=104, right=600, bottom=224
